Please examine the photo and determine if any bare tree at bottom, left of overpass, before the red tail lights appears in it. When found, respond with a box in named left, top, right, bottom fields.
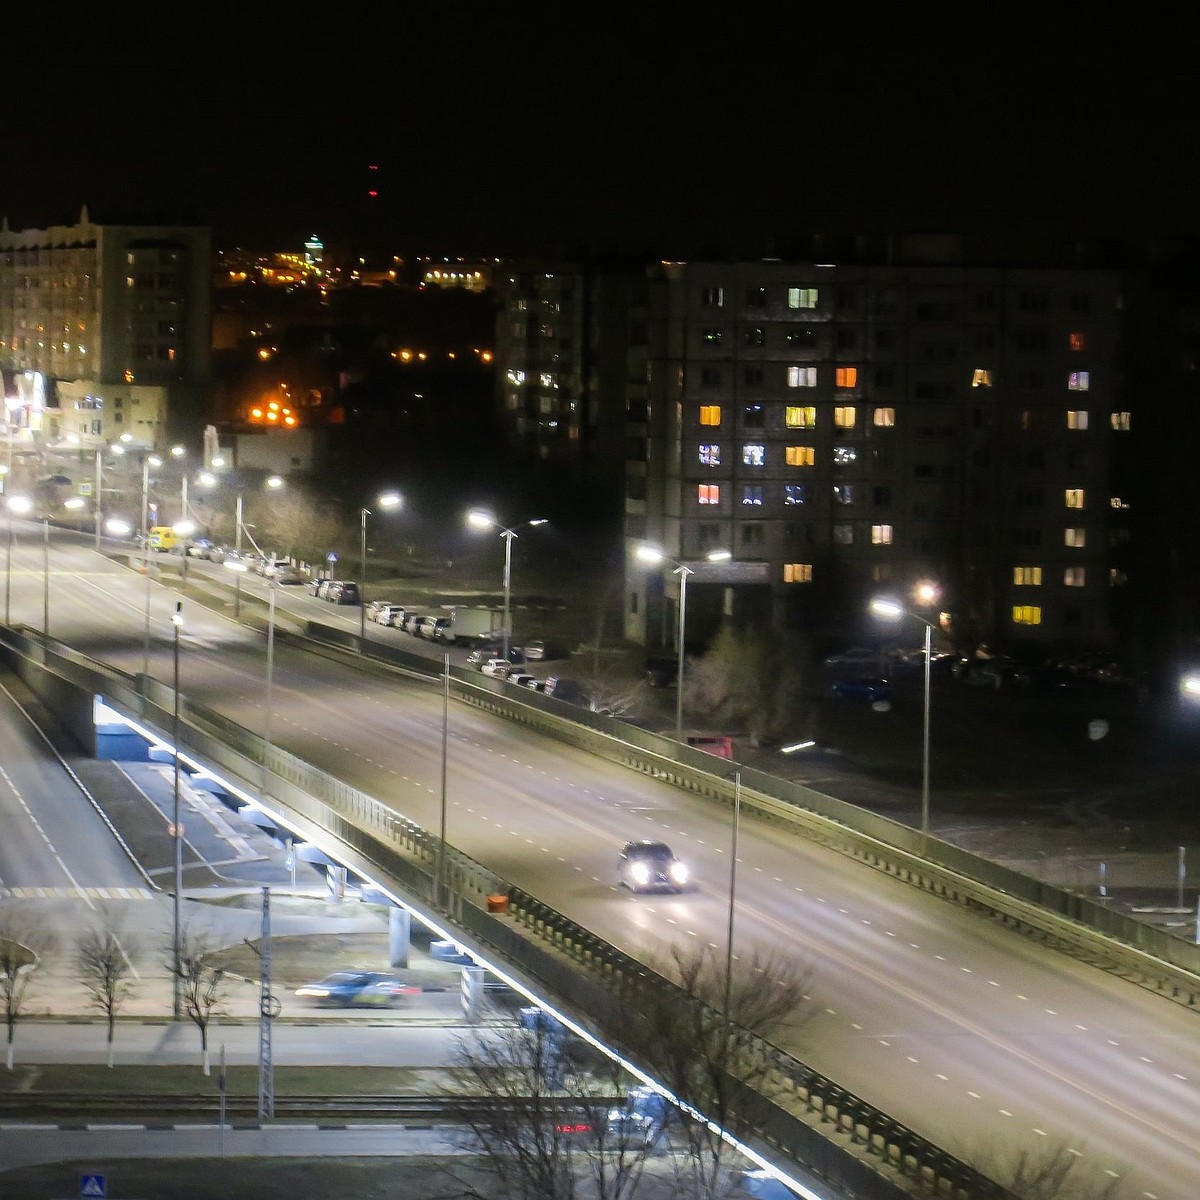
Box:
left=451, top=1014, right=649, bottom=1200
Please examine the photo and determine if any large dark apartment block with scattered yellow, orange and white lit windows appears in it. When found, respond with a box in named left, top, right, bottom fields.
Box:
left=625, top=241, right=1133, bottom=646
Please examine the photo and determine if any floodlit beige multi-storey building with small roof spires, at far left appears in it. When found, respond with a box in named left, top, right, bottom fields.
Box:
left=0, top=209, right=211, bottom=446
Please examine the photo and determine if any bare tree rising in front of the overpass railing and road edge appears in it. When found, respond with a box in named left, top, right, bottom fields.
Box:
left=611, top=947, right=811, bottom=1200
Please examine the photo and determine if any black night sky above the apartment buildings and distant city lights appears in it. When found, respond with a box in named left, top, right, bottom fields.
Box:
left=0, top=24, right=1200, bottom=257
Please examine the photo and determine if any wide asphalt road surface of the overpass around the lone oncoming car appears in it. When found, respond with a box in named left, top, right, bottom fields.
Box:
left=2, top=536, right=1200, bottom=1200
